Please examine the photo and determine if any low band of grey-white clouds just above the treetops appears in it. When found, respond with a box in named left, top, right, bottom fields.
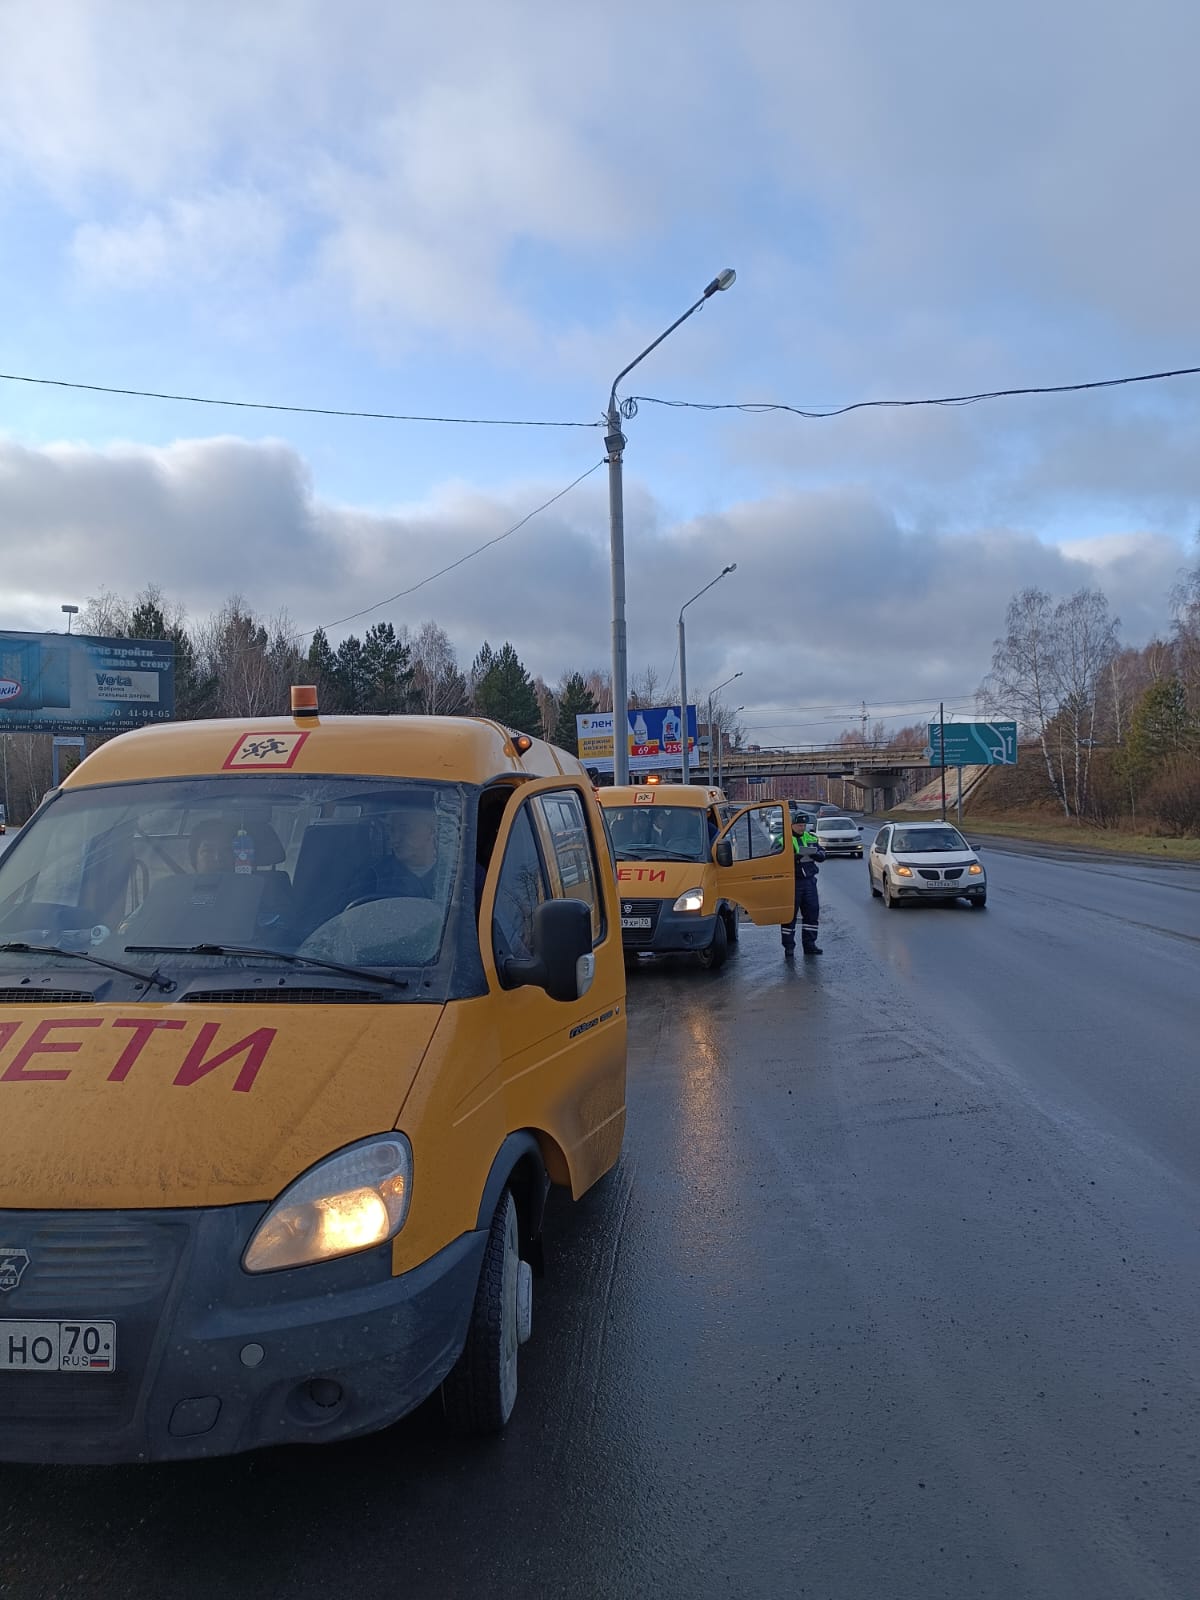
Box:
left=0, top=438, right=1182, bottom=739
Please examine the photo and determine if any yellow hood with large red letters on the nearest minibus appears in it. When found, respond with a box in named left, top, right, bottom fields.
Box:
left=0, top=1003, right=443, bottom=1210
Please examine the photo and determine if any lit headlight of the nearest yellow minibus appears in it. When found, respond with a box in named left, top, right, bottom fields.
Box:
left=242, top=1133, right=413, bottom=1272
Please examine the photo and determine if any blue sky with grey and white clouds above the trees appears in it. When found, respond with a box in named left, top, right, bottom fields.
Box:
left=0, top=0, right=1200, bottom=742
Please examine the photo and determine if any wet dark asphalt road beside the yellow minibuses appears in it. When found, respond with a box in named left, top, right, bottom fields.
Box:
left=0, top=829, right=1200, bottom=1600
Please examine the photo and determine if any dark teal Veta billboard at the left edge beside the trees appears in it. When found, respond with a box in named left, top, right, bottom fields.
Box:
left=0, top=634, right=174, bottom=733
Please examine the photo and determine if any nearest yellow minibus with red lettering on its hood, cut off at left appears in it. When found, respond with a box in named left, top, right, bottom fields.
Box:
left=0, top=690, right=626, bottom=1462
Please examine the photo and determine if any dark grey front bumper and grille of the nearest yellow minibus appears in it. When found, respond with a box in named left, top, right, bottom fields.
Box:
left=0, top=1205, right=486, bottom=1462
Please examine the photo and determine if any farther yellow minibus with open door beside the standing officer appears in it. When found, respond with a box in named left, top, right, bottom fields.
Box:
left=598, top=784, right=795, bottom=968
